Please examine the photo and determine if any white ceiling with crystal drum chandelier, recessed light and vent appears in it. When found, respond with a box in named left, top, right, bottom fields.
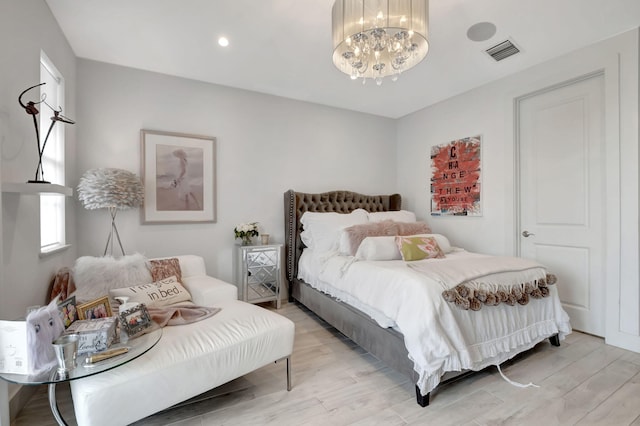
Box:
left=46, top=0, right=640, bottom=118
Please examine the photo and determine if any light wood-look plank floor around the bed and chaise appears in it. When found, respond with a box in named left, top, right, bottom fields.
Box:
left=11, top=304, right=640, bottom=426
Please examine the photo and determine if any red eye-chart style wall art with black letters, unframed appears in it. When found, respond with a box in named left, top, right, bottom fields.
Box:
left=431, top=136, right=482, bottom=216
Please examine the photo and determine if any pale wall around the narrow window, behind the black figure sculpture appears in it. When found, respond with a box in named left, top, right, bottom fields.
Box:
left=0, top=0, right=76, bottom=425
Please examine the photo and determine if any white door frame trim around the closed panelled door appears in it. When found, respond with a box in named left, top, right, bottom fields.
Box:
left=512, top=65, right=624, bottom=351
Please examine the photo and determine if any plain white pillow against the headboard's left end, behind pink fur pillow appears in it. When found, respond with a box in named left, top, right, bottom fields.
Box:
left=300, top=209, right=369, bottom=253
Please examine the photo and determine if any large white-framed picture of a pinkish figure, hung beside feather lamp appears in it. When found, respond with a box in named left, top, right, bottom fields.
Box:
left=140, top=129, right=216, bottom=223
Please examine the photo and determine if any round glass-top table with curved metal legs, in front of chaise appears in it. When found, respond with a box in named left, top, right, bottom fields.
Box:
left=0, top=325, right=162, bottom=426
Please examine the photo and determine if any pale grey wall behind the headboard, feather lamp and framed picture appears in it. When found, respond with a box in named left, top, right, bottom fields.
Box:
left=75, top=60, right=396, bottom=280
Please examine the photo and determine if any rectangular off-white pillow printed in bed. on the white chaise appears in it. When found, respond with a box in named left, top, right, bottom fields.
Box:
left=109, top=277, right=191, bottom=308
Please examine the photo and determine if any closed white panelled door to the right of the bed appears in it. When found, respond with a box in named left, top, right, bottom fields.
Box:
left=517, top=74, right=604, bottom=336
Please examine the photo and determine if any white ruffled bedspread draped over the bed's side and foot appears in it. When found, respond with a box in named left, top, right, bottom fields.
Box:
left=298, top=250, right=571, bottom=395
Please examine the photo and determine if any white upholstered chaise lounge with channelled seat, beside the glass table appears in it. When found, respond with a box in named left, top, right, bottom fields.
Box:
left=71, top=255, right=294, bottom=426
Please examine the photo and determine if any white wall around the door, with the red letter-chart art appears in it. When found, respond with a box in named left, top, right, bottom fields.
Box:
left=397, top=30, right=640, bottom=351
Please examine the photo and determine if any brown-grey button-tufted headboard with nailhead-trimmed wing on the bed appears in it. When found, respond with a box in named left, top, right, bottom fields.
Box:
left=284, top=189, right=402, bottom=289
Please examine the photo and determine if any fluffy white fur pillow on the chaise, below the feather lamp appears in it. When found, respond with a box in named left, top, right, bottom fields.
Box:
left=73, top=253, right=152, bottom=303
